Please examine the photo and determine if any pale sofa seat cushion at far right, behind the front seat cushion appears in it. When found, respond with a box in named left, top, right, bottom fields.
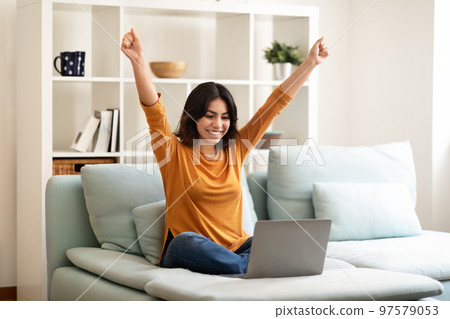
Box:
left=327, top=230, right=450, bottom=280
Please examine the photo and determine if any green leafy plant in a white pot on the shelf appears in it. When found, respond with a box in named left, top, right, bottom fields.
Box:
left=264, top=41, right=304, bottom=80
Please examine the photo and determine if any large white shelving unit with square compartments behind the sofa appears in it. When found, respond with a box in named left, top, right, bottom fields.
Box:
left=17, top=0, right=318, bottom=300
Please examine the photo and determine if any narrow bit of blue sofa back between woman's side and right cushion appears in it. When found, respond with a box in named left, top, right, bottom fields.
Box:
left=247, top=171, right=269, bottom=220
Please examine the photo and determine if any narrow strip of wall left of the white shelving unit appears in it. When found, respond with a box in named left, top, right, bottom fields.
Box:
left=0, top=0, right=16, bottom=287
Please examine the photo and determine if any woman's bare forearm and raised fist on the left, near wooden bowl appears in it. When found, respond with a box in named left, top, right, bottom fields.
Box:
left=121, top=28, right=158, bottom=106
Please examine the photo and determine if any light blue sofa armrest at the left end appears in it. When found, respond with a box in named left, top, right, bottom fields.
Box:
left=45, top=175, right=100, bottom=296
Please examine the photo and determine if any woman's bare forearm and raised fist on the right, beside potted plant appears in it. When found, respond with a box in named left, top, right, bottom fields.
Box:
left=280, top=37, right=328, bottom=98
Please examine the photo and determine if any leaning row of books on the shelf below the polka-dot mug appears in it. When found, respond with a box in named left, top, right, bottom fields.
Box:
left=70, top=108, right=119, bottom=153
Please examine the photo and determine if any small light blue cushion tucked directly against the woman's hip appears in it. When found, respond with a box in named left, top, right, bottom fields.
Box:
left=132, top=200, right=166, bottom=265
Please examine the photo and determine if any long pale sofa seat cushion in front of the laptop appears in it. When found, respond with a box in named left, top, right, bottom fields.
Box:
left=145, top=268, right=442, bottom=301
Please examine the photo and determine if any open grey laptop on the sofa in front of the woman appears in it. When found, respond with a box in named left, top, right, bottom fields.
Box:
left=232, top=219, right=331, bottom=278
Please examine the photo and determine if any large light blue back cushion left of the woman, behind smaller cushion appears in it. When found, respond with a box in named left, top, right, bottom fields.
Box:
left=81, top=164, right=164, bottom=255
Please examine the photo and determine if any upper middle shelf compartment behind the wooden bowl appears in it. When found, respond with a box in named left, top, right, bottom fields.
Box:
left=123, top=8, right=250, bottom=80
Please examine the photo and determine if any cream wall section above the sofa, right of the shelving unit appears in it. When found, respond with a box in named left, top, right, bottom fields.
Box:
left=347, top=0, right=433, bottom=228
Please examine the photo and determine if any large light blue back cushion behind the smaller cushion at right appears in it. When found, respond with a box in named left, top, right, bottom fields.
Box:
left=267, top=141, right=416, bottom=219
